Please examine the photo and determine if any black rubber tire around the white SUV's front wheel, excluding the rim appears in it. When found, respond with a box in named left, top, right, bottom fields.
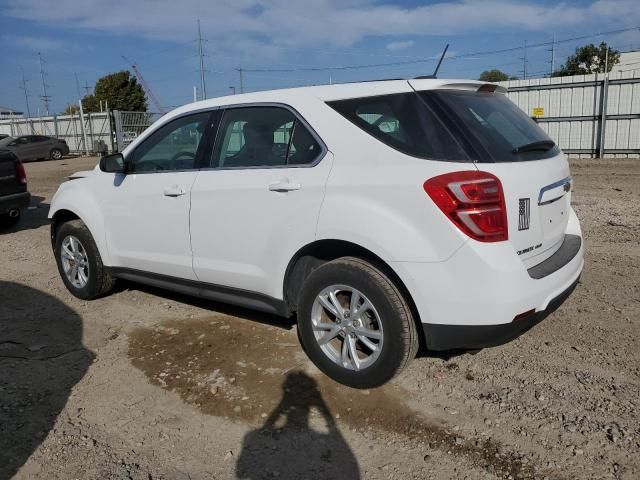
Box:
left=54, top=220, right=116, bottom=300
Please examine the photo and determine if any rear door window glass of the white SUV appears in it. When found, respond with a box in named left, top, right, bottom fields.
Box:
left=211, top=107, right=321, bottom=168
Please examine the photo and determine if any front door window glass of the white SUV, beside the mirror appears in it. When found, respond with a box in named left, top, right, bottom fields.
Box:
left=131, top=112, right=210, bottom=173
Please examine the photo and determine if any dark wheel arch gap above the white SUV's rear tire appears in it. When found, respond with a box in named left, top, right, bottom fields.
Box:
left=283, top=239, right=424, bottom=346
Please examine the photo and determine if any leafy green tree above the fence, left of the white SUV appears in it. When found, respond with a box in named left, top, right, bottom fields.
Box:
left=82, top=70, right=147, bottom=112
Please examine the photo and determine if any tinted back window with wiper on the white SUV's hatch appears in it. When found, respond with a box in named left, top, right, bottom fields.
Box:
left=419, top=90, right=559, bottom=162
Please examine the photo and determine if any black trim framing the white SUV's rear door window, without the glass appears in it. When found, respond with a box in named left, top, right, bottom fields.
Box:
left=205, top=102, right=329, bottom=171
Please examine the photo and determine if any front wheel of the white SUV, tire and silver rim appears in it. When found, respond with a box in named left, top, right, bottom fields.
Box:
left=55, top=220, right=115, bottom=300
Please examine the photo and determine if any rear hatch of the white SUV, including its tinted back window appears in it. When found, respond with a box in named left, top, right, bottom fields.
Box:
left=410, top=80, right=571, bottom=268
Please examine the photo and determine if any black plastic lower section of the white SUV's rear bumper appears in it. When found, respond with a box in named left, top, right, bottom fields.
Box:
left=422, top=280, right=578, bottom=351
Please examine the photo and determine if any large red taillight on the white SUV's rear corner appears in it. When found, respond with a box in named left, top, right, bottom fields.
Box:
left=424, top=171, right=509, bottom=242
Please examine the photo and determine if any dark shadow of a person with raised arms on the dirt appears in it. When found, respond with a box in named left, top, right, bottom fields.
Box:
left=236, top=372, right=360, bottom=480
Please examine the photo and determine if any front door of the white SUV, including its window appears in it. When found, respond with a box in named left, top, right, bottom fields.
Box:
left=98, top=112, right=211, bottom=280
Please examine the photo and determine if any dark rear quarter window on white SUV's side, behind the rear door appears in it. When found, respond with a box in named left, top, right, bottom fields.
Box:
left=328, top=93, right=469, bottom=162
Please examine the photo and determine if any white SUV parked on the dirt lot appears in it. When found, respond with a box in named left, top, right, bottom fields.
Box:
left=49, top=79, right=583, bottom=388
